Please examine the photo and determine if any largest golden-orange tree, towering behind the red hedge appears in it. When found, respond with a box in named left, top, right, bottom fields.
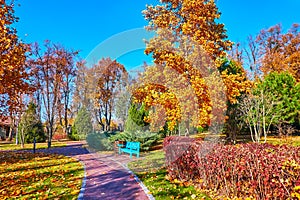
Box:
left=133, top=0, right=250, bottom=134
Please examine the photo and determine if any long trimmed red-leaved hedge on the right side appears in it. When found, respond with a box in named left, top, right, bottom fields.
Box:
left=164, top=136, right=300, bottom=199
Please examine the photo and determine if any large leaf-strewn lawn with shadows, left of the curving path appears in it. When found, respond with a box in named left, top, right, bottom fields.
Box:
left=0, top=151, right=84, bottom=199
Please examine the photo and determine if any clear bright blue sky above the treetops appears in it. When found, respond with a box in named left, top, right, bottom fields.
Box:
left=15, top=0, right=300, bottom=69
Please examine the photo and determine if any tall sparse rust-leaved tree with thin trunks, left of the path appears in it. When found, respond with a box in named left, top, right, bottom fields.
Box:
left=29, top=40, right=78, bottom=148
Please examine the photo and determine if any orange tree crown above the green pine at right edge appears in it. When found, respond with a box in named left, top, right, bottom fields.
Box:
left=248, top=24, right=300, bottom=82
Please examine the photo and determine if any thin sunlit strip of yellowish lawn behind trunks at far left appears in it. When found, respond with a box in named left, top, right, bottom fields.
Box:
left=0, top=142, right=67, bottom=150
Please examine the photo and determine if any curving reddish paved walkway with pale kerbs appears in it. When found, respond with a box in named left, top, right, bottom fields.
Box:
left=39, top=142, right=151, bottom=200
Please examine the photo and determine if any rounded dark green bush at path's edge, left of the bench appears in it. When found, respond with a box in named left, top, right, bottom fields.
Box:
left=86, top=133, right=113, bottom=151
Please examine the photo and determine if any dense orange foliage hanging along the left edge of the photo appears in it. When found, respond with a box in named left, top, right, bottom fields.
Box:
left=0, top=0, right=33, bottom=115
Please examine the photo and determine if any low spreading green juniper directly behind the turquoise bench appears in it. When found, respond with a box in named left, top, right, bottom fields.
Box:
left=110, top=131, right=160, bottom=151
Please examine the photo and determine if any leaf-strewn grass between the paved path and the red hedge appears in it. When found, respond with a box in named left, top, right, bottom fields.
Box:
left=128, top=150, right=210, bottom=200
